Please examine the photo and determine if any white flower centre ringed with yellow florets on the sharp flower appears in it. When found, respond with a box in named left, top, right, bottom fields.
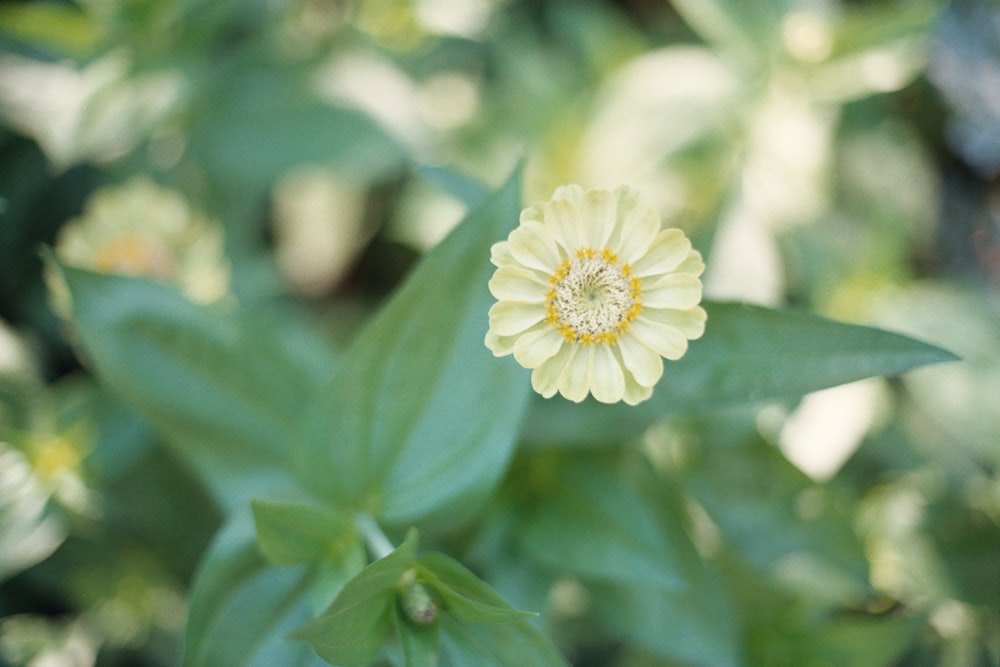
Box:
left=545, top=248, right=642, bottom=345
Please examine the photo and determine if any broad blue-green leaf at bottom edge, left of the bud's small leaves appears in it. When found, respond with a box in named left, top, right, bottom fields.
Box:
left=181, top=515, right=324, bottom=667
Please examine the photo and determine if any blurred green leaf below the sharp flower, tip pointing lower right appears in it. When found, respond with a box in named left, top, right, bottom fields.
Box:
left=520, top=458, right=686, bottom=588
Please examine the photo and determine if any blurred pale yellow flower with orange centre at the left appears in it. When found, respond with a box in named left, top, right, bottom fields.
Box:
left=46, top=178, right=229, bottom=318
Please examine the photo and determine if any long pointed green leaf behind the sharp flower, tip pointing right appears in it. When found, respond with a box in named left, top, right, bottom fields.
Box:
left=524, top=302, right=957, bottom=444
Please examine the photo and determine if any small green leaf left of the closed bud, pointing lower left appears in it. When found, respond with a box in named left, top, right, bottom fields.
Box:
left=293, top=531, right=417, bottom=667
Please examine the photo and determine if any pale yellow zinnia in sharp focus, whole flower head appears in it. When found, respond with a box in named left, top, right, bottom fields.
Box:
left=486, top=185, right=706, bottom=405
